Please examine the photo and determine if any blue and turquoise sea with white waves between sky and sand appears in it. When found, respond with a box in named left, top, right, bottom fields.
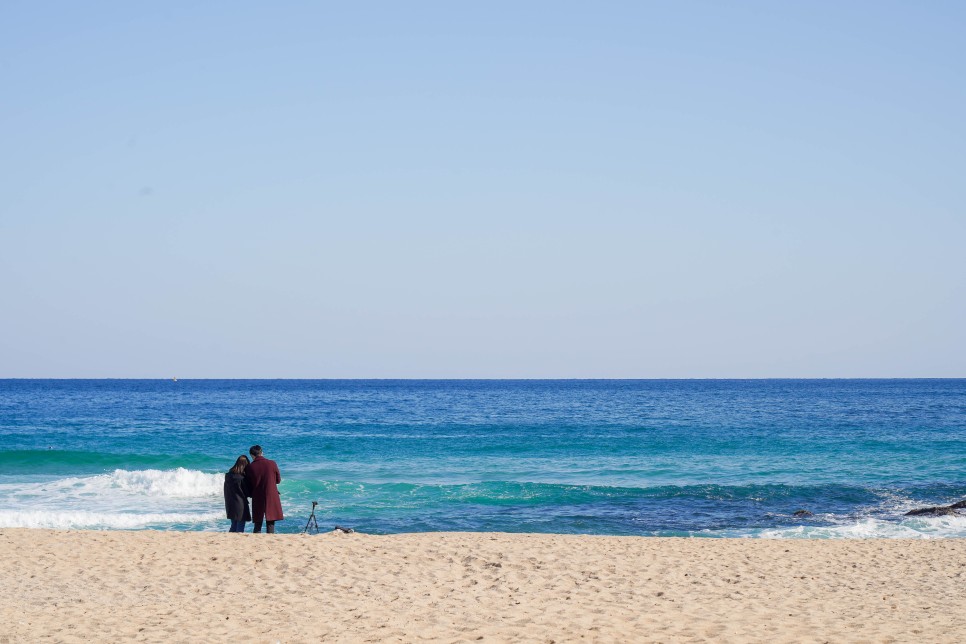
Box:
left=0, top=380, right=966, bottom=538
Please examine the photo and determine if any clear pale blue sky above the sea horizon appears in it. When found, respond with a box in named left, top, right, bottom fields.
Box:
left=0, top=0, right=966, bottom=378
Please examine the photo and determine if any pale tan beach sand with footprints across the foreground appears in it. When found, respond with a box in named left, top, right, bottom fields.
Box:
left=0, top=528, right=966, bottom=642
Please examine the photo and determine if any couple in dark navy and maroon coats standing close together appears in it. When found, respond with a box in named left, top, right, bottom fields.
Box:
left=225, top=445, right=285, bottom=534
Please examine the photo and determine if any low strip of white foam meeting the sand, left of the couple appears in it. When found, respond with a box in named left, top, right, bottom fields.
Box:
left=0, top=510, right=224, bottom=530
